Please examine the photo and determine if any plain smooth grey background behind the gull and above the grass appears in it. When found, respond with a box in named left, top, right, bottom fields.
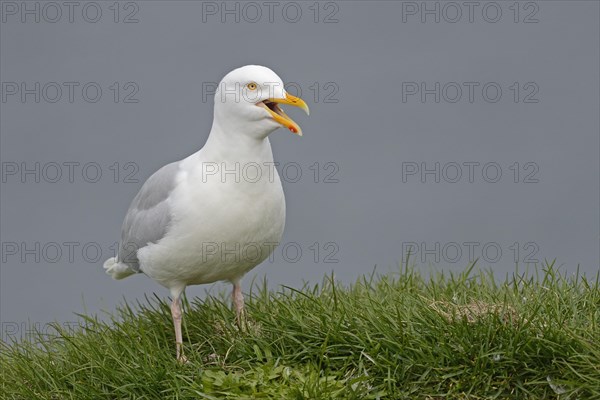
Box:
left=0, top=1, right=600, bottom=339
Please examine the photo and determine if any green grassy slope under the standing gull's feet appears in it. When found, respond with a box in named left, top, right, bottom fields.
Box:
left=0, top=264, right=600, bottom=400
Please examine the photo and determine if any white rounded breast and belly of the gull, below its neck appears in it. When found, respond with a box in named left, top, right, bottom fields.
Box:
left=138, top=158, right=285, bottom=287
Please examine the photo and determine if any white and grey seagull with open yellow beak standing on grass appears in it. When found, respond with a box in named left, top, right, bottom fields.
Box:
left=104, top=65, right=309, bottom=362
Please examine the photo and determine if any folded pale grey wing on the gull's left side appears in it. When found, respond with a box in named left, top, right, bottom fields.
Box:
left=118, top=161, right=179, bottom=272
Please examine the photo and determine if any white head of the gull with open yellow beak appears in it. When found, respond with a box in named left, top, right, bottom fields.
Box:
left=214, top=65, right=309, bottom=139
